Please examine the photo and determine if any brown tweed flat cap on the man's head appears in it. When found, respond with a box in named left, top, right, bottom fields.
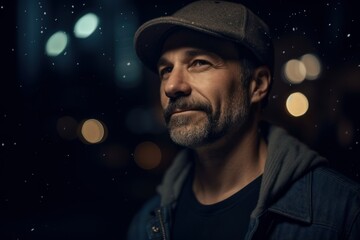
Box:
left=134, top=0, right=273, bottom=72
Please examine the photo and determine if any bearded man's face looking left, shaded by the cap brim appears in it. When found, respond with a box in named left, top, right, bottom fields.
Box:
left=158, top=30, right=250, bottom=148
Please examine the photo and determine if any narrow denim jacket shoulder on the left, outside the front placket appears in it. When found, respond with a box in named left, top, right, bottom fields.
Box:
left=128, top=195, right=160, bottom=240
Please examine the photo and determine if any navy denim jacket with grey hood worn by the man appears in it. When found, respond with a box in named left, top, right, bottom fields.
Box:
left=128, top=126, right=360, bottom=240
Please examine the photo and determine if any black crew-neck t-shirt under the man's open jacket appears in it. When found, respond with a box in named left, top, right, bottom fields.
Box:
left=171, top=171, right=261, bottom=240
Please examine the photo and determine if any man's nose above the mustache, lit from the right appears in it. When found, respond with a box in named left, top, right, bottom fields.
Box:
left=163, top=67, right=191, bottom=99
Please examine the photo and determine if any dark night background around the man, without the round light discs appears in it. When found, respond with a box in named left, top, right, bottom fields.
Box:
left=0, top=0, right=360, bottom=239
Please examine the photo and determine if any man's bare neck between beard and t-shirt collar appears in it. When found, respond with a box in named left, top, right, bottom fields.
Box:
left=193, top=121, right=267, bottom=204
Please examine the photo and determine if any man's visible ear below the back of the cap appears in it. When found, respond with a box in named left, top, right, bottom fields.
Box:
left=249, top=66, right=271, bottom=103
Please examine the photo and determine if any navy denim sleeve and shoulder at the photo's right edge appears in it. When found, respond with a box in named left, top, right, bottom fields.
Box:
left=311, top=167, right=360, bottom=239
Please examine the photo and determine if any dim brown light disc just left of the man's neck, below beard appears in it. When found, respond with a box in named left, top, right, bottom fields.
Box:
left=134, top=142, right=161, bottom=170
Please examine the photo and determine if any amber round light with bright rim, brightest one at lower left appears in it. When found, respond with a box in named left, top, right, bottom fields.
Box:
left=81, top=119, right=107, bottom=144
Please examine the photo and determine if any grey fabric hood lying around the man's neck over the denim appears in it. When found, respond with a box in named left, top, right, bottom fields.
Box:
left=157, top=125, right=326, bottom=217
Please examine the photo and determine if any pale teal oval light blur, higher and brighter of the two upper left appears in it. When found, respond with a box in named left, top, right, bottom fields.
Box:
left=74, top=13, right=99, bottom=38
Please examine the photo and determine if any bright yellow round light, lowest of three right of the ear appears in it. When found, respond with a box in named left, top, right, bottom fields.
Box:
left=286, top=92, right=309, bottom=117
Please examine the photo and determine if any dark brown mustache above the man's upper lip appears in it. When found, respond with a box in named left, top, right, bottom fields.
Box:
left=163, top=97, right=212, bottom=123
